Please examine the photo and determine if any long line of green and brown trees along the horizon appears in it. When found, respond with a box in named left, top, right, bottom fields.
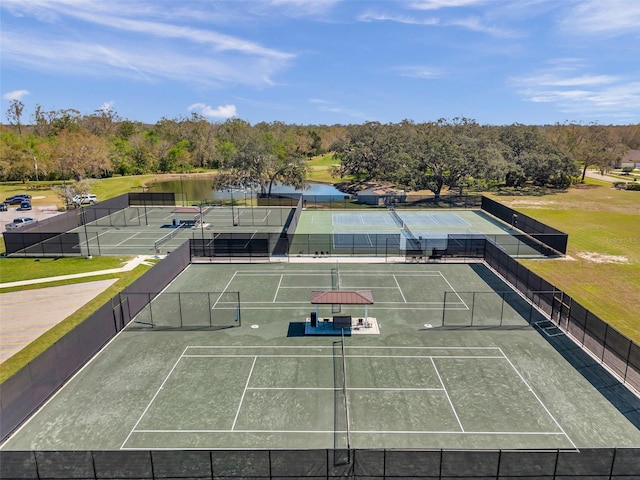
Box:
left=0, top=100, right=640, bottom=195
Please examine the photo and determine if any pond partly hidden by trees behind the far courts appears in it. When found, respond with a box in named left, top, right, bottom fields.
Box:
left=148, top=177, right=348, bottom=202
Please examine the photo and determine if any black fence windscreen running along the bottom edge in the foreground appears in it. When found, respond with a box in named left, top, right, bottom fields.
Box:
left=0, top=448, right=640, bottom=480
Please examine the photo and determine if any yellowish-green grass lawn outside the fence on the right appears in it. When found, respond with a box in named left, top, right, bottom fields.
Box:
left=493, top=181, right=640, bottom=343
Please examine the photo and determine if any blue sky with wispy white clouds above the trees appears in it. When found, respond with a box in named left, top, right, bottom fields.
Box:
left=0, top=0, right=640, bottom=125
